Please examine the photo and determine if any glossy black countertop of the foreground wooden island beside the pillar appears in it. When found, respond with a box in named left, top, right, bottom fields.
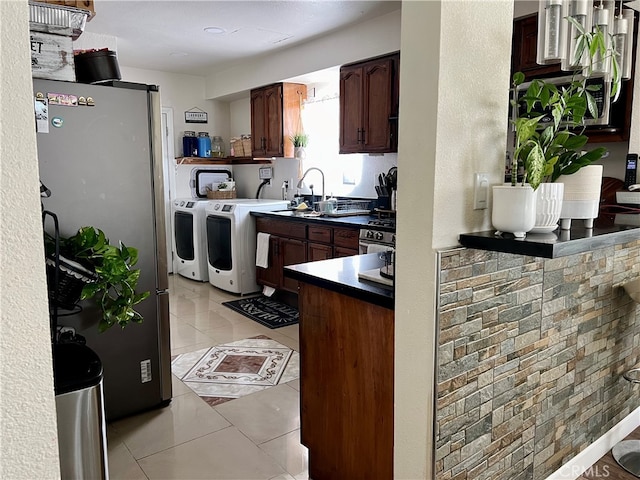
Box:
left=284, top=253, right=394, bottom=310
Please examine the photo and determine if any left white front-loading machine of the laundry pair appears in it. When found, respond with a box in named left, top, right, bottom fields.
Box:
left=173, top=198, right=209, bottom=282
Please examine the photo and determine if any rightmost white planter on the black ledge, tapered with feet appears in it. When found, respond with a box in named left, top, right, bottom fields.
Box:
left=558, top=165, right=602, bottom=230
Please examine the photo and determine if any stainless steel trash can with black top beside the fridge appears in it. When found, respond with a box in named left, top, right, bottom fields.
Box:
left=53, top=343, right=109, bottom=480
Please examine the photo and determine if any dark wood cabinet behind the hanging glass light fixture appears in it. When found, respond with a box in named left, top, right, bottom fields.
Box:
left=511, top=13, right=638, bottom=143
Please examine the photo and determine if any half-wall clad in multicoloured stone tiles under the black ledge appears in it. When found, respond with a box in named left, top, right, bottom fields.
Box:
left=435, top=241, right=640, bottom=480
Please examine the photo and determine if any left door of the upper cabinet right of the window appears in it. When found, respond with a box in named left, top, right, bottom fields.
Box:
left=340, top=66, right=363, bottom=153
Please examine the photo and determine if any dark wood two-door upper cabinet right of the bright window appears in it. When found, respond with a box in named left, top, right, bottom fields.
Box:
left=340, top=52, right=400, bottom=153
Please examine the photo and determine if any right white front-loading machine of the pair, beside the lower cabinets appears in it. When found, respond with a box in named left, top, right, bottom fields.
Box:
left=205, top=198, right=288, bottom=295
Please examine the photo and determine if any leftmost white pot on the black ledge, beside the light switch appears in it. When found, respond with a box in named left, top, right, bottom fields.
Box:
left=491, top=185, right=536, bottom=238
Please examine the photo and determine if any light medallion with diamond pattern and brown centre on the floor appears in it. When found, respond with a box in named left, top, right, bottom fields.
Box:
left=171, top=335, right=300, bottom=407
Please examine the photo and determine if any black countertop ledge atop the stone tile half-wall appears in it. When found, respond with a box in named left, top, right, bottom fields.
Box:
left=459, top=216, right=640, bottom=258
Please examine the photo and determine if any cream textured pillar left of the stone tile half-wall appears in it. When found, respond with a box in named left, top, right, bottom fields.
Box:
left=394, top=0, right=513, bottom=479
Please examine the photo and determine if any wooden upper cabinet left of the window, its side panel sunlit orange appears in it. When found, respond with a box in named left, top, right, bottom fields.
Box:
left=251, top=83, right=307, bottom=157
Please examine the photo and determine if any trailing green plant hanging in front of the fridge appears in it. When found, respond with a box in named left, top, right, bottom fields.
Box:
left=45, top=227, right=150, bottom=332
